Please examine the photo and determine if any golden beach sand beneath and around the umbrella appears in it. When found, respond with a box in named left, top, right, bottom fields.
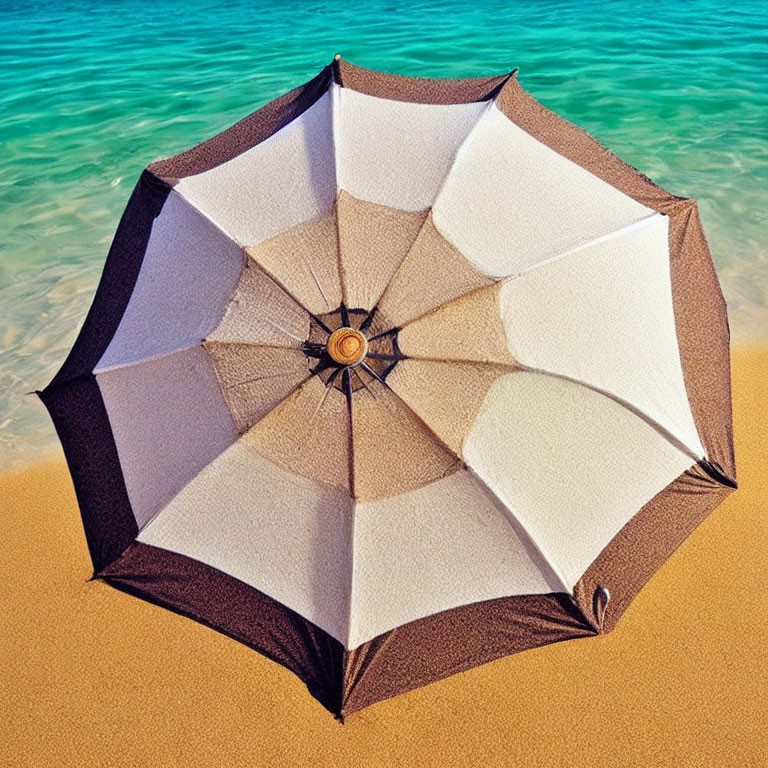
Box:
left=0, top=350, right=768, bottom=768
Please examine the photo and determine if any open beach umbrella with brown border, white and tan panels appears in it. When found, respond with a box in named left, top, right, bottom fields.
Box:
left=41, top=57, right=736, bottom=718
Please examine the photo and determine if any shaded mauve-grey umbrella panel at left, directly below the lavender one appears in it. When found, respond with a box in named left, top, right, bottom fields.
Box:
left=96, top=345, right=237, bottom=528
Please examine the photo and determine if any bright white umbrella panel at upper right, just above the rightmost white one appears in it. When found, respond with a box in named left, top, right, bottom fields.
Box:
left=433, top=106, right=653, bottom=277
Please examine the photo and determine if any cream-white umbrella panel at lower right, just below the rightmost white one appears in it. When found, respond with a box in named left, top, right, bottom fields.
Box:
left=464, top=371, right=693, bottom=587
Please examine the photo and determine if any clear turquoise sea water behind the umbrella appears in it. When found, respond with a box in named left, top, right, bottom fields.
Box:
left=0, top=0, right=768, bottom=466
